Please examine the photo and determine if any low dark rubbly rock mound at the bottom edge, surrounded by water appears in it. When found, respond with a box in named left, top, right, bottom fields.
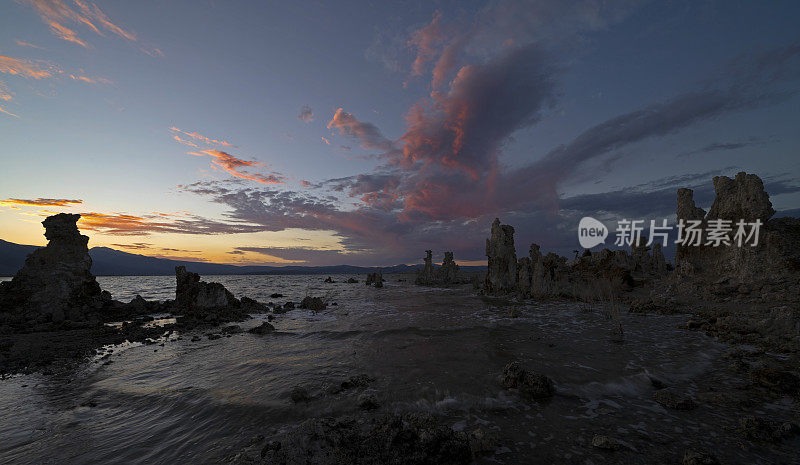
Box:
left=241, top=413, right=472, bottom=465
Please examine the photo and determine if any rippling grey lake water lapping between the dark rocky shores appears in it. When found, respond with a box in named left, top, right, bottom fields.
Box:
left=0, top=275, right=798, bottom=464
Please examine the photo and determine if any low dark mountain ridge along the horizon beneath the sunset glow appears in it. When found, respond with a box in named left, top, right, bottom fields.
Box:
left=0, top=239, right=486, bottom=276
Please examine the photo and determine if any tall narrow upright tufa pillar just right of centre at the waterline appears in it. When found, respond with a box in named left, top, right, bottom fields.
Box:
left=483, top=218, right=517, bottom=294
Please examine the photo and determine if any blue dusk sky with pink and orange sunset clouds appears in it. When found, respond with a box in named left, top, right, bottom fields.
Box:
left=0, top=0, right=800, bottom=266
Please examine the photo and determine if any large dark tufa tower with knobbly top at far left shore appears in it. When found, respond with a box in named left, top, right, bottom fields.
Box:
left=0, top=213, right=104, bottom=323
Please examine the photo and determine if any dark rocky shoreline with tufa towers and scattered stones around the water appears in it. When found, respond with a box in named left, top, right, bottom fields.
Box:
left=0, top=173, right=800, bottom=464
